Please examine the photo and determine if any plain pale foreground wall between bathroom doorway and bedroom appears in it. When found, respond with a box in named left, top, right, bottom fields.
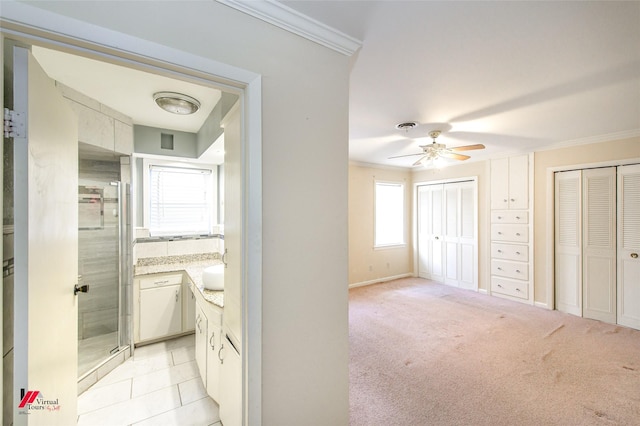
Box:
left=5, top=1, right=349, bottom=426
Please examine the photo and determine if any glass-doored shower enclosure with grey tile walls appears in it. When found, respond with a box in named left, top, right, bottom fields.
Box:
left=78, top=179, right=131, bottom=377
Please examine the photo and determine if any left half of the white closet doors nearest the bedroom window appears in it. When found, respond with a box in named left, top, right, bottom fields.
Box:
left=418, top=185, right=444, bottom=282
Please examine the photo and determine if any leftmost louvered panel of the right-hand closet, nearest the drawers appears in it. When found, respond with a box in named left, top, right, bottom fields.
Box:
left=555, top=170, right=582, bottom=316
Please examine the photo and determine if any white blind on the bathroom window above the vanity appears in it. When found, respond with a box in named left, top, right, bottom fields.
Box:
left=149, top=165, right=214, bottom=235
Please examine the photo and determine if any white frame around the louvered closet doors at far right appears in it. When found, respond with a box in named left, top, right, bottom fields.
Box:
left=536, top=158, right=640, bottom=310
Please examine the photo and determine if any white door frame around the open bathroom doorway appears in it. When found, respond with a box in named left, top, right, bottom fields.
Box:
left=0, top=1, right=262, bottom=425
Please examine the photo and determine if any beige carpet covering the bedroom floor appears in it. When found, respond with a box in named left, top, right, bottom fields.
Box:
left=349, top=278, right=640, bottom=426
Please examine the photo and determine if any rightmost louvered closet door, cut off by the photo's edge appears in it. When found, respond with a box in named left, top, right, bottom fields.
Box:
left=618, top=165, right=640, bottom=329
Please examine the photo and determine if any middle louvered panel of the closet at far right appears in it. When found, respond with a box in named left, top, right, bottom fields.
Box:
left=582, top=167, right=617, bottom=324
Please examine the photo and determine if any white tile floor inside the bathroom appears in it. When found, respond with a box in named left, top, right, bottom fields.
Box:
left=78, top=335, right=222, bottom=426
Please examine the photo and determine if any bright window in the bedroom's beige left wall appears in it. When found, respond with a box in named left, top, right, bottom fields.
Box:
left=375, top=182, right=404, bottom=247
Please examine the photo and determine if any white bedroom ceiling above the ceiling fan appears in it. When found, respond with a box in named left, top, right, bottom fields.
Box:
left=281, top=0, right=640, bottom=167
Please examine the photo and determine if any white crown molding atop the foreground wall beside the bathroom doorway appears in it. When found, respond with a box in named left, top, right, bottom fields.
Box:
left=216, top=0, right=362, bottom=56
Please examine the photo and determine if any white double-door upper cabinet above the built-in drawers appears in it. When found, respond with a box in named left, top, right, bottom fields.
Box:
left=491, top=155, right=529, bottom=210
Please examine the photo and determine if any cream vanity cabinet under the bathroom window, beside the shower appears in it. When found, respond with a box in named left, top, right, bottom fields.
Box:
left=134, top=272, right=195, bottom=343
